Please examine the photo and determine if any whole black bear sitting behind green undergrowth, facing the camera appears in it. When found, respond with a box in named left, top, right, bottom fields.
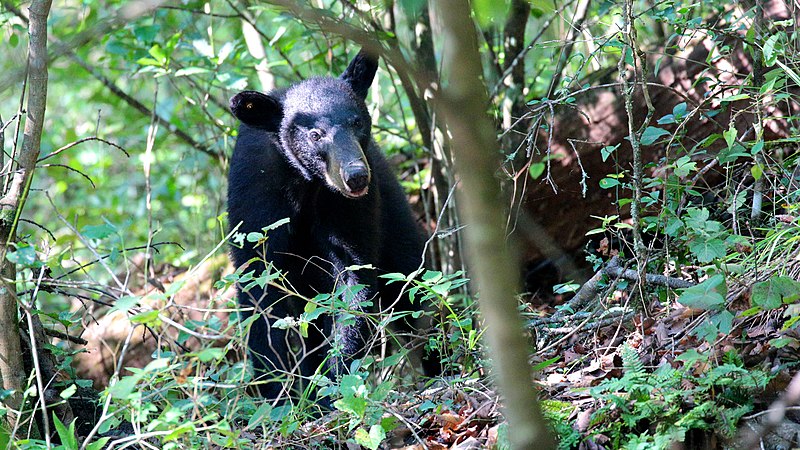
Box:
left=228, top=51, right=437, bottom=399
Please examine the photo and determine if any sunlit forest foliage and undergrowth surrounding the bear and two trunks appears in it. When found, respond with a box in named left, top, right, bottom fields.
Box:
left=0, top=0, right=800, bottom=449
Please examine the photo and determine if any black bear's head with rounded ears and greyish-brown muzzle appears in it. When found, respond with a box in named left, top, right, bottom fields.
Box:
left=230, top=50, right=378, bottom=198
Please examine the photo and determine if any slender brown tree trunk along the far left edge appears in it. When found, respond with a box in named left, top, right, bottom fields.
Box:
left=0, top=0, right=51, bottom=430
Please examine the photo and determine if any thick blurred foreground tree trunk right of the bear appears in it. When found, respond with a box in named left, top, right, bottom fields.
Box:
left=430, top=0, right=553, bottom=450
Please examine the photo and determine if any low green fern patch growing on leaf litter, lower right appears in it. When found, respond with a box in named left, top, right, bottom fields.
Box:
left=590, top=346, right=771, bottom=449
